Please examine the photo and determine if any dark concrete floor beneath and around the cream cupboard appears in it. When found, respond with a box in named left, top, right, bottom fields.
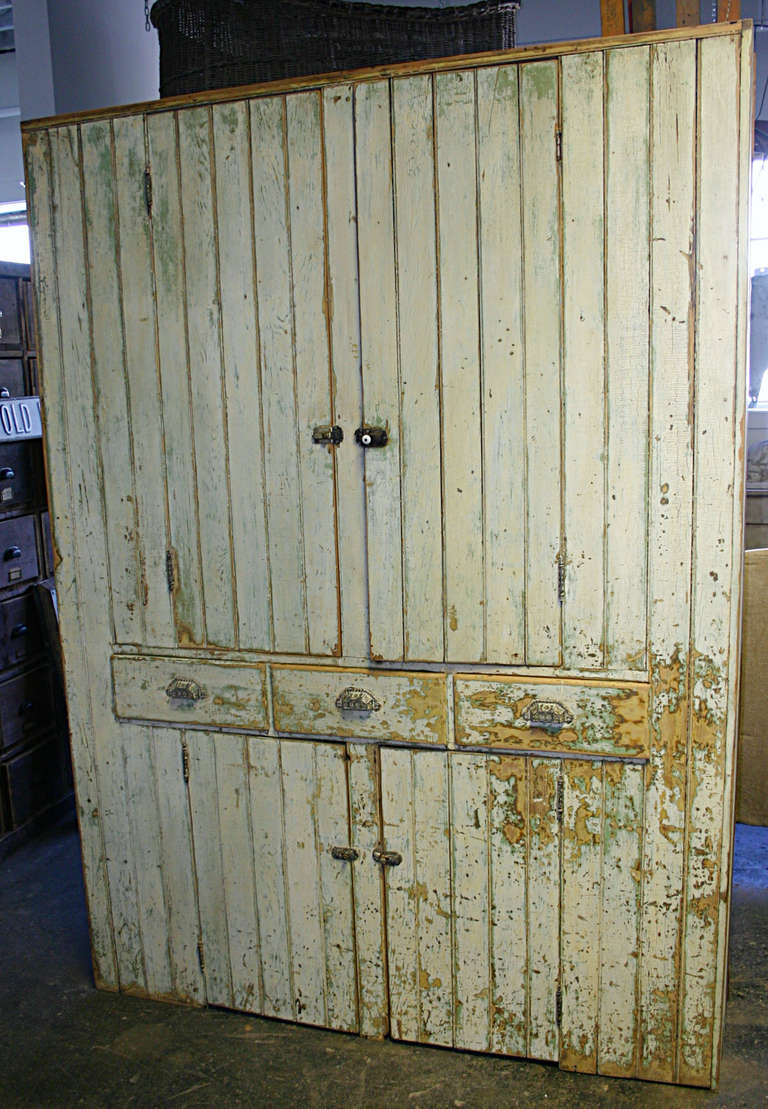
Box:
left=0, top=822, right=768, bottom=1109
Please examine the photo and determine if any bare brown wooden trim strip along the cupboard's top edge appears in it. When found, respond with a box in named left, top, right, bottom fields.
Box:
left=21, top=19, right=752, bottom=141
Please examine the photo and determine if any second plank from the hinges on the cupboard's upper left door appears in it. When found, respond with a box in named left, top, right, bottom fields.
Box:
left=178, top=108, right=237, bottom=647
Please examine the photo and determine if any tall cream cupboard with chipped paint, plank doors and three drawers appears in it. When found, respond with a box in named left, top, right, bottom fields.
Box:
left=24, top=23, right=752, bottom=1086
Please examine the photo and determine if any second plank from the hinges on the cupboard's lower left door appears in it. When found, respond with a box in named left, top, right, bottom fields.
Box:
left=214, top=735, right=263, bottom=1013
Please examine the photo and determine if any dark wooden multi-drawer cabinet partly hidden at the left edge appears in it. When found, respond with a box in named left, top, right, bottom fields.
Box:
left=0, top=262, right=72, bottom=858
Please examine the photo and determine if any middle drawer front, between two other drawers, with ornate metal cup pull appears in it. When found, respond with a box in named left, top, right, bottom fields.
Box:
left=272, top=665, right=448, bottom=743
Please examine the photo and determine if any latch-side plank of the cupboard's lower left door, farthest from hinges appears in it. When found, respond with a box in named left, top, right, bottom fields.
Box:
left=315, top=743, right=359, bottom=1032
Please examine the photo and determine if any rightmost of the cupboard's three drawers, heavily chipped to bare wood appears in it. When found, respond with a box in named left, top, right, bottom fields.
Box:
left=455, top=675, right=648, bottom=759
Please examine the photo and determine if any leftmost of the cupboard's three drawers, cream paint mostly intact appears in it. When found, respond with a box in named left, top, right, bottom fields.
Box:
left=112, top=655, right=268, bottom=732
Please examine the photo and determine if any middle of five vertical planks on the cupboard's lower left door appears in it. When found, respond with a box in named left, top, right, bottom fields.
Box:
left=247, top=739, right=294, bottom=1019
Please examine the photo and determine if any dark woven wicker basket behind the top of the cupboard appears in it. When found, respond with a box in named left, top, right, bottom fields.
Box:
left=152, top=0, right=520, bottom=96
